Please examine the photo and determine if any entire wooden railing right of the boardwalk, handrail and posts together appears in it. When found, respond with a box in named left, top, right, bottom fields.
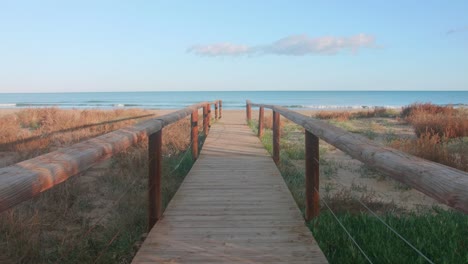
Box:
left=246, top=100, right=468, bottom=220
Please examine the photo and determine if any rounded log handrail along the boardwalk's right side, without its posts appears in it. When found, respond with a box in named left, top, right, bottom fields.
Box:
left=247, top=100, right=468, bottom=216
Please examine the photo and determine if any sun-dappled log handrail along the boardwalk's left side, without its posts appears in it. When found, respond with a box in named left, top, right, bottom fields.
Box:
left=0, top=100, right=220, bottom=218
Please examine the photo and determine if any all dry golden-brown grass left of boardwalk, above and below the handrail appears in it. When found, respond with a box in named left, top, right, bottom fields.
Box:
left=0, top=109, right=202, bottom=263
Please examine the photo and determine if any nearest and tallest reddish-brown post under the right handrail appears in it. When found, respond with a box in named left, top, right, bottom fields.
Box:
left=305, top=130, right=320, bottom=221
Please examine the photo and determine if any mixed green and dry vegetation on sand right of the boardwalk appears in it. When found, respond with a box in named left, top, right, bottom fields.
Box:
left=247, top=109, right=468, bottom=263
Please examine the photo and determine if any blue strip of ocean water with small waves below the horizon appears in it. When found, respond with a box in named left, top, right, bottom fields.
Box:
left=0, top=91, right=468, bottom=109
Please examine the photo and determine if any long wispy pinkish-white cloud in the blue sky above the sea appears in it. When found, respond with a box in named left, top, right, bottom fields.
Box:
left=187, top=34, right=377, bottom=56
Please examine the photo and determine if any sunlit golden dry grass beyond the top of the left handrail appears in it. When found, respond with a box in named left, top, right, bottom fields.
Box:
left=0, top=108, right=151, bottom=162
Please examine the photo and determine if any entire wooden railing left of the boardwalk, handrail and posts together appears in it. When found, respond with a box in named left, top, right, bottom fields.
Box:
left=0, top=100, right=222, bottom=228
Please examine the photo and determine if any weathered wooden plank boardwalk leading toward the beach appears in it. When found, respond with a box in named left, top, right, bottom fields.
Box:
left=133, top=112, right=327, bottom=263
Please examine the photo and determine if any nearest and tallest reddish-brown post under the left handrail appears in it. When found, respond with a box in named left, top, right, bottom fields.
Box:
left=148, top=129, right=162, bottom=230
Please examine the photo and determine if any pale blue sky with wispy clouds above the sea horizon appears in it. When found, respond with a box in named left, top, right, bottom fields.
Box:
left=0, top=0, right=468, bottom=93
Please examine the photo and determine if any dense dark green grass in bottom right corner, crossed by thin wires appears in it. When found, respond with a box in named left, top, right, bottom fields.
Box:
left=308, top=209, right=468, bottom=263
